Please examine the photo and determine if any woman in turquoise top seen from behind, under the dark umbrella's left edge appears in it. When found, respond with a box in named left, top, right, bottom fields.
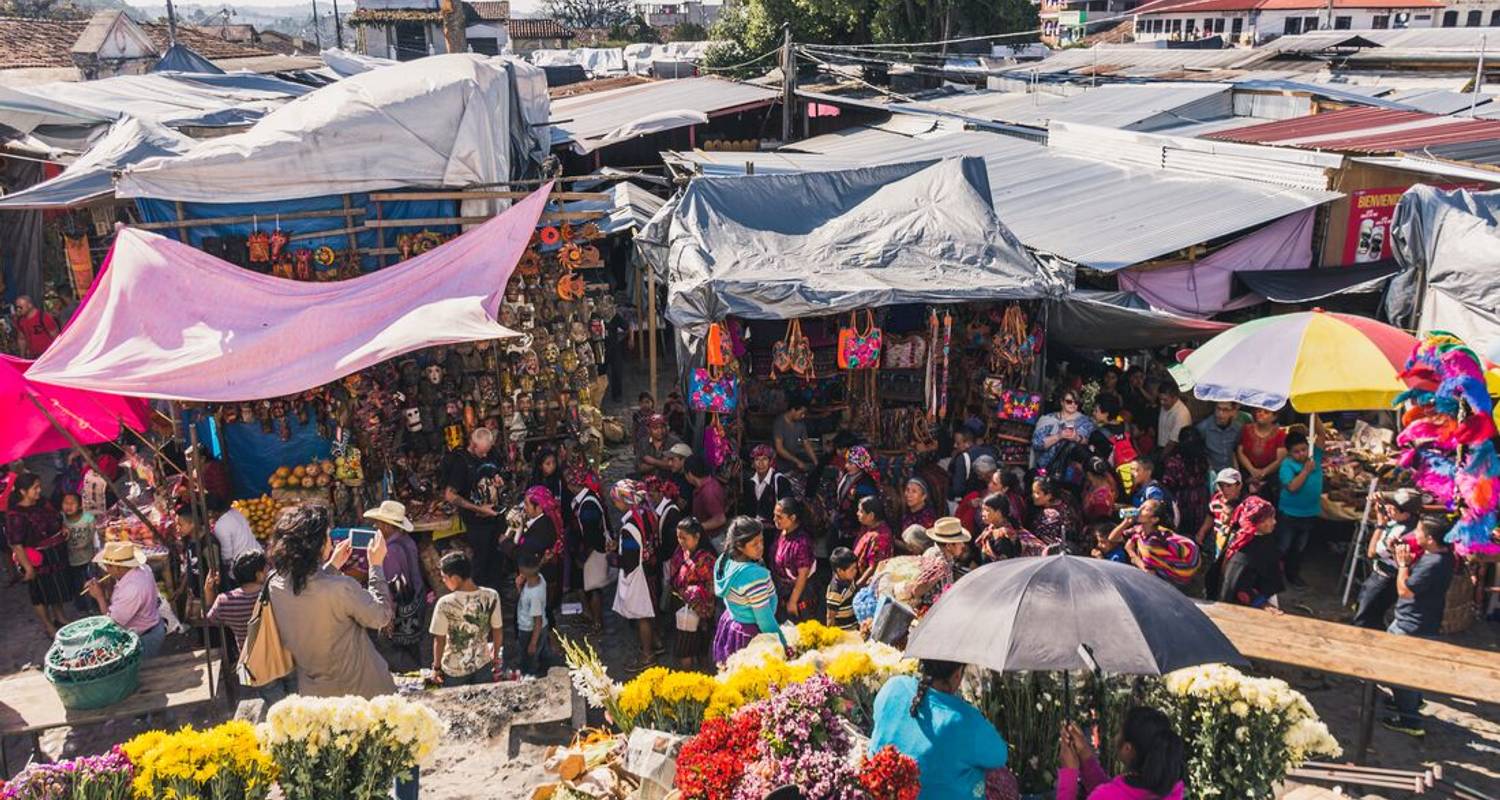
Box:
left=870, top=660, right=1008, bottom=800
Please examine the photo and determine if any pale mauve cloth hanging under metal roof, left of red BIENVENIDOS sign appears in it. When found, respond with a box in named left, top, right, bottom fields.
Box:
left=1119, top=209, right=1314, bottom=317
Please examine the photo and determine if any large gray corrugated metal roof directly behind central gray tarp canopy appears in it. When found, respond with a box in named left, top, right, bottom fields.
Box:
left=671, top=126, right=1340, bottom=272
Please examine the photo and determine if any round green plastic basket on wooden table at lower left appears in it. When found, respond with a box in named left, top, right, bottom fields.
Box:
left=44, top=617, right=141, bottom=710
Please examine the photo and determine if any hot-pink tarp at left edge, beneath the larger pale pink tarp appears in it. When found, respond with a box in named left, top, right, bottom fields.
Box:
left=0, top=356, right=152, bottom=464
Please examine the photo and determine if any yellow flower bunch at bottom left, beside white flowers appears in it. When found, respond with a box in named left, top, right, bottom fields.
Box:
left=120, top=720, right=276, bottom=800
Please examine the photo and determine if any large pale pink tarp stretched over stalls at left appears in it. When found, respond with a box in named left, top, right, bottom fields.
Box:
left=27, top=185, right=551, bottom=402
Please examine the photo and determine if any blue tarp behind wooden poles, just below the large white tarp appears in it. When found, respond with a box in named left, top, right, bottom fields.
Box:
left=135, top=194, right=458, bottom=272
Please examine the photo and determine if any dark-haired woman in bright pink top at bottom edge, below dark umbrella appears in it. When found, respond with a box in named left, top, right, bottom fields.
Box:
left=1058, top=705, right=1187, bottom=800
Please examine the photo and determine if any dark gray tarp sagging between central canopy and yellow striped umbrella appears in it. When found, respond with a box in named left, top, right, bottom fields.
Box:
left=1047, top=290, right=1235, bottom=350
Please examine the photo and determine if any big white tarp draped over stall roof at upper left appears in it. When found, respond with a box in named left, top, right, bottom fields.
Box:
left=117, top=54, right=549, bottom=203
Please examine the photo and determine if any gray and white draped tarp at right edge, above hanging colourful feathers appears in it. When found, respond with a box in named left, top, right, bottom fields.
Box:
left=1386, top=185, right=1500, bottom=353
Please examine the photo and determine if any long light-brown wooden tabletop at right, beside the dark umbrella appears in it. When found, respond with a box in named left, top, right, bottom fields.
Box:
left=1199, top=603, right=1500, bottom=701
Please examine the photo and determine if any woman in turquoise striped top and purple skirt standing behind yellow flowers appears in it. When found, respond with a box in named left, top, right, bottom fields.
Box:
left=714, top=516, right=786, bottom=666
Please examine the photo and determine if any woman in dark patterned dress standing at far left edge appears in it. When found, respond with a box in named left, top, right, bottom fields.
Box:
left=5, top=473, right=72, bottom=638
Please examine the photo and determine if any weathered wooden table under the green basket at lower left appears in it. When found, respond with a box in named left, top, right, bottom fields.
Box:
left=0, top=650, right=213, bottom=734
